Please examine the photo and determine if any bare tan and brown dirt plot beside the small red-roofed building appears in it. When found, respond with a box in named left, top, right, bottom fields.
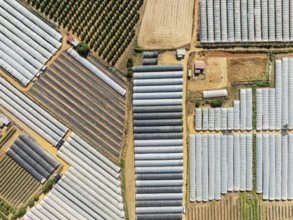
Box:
left=188, top=52, right=267, bottom=92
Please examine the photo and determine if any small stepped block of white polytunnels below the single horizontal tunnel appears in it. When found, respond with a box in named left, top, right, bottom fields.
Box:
left=194, top=88, right=253, bottom=131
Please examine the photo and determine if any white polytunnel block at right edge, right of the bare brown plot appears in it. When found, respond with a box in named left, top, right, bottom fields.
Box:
left=256, top=58, right=293, bottom=131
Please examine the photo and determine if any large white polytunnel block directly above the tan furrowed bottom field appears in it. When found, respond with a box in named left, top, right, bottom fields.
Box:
left=189, top=134, right=253, bottom=202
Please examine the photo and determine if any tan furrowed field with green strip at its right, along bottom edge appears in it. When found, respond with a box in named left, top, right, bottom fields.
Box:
left=187, top=194, right=260, bottom=220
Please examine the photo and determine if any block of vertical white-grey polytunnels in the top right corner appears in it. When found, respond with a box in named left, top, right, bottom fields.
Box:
left=199, top=0, right=293, bottom=43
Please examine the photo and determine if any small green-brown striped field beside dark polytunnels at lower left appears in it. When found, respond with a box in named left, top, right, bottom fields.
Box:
left=0, top=155, right=42, bottom=207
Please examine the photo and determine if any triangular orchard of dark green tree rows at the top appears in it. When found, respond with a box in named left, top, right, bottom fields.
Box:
left=27, top=0, right=143, bottom=65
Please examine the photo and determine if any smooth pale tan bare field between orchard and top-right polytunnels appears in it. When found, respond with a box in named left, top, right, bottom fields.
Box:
left=138, top=0, right=194, bottom=49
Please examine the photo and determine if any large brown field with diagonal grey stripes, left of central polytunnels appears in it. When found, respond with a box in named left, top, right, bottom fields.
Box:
left=28, top=53, right=125, bottom=162
